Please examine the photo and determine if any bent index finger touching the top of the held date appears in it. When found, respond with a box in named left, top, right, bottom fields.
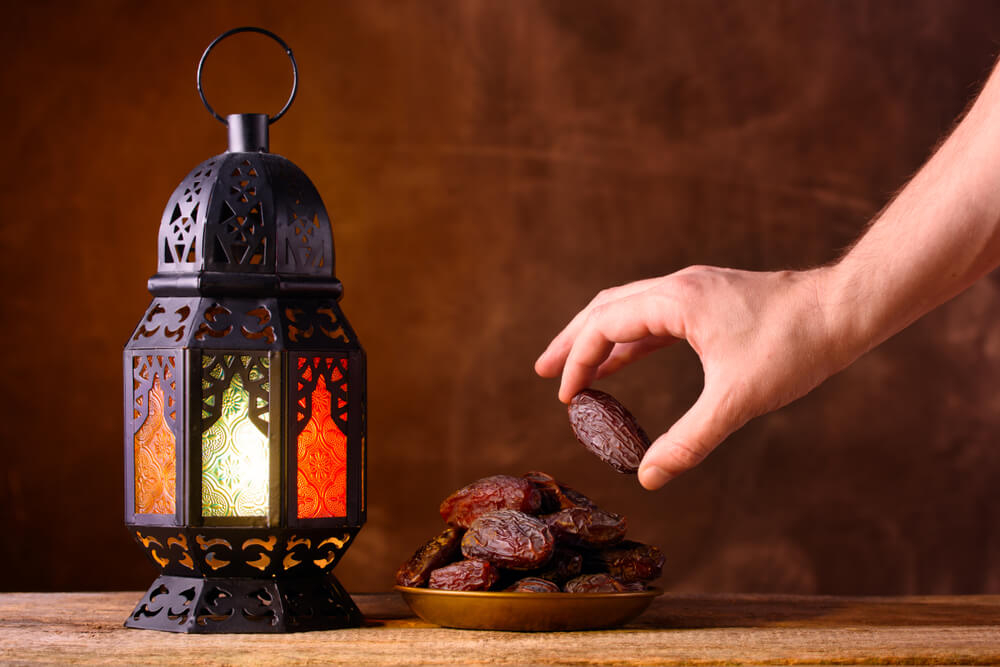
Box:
left=559, top=292, right=682, bottom=403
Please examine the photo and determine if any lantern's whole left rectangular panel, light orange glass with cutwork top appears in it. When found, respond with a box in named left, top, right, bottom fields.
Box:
left=132, top=355, right=177, bottom=514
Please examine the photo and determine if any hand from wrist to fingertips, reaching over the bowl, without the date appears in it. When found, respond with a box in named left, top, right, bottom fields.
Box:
left=535, top=266, right=856, bottom=489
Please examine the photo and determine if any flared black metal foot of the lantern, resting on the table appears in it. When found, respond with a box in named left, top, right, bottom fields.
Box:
left=125, top=575, right=363, bottom=634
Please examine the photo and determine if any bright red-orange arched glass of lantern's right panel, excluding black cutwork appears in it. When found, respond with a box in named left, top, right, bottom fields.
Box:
left=298, top=375, right=347, bottom=519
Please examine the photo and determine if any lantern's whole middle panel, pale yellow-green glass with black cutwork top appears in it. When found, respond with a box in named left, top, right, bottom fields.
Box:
left=201, top=354, right=271, bottom=517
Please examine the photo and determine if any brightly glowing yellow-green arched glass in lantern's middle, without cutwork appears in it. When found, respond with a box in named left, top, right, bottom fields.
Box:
left=201, top=374, right=270, bottom=516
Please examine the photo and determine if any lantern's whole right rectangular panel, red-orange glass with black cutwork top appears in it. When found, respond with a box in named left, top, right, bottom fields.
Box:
left=296, top=356, right=348, bottom=519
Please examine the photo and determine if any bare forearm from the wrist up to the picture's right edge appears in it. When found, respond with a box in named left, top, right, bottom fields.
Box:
left=817, top=60, right=1000, bottom=363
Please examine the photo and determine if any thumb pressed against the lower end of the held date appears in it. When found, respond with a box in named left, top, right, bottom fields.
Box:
left=639, top=387, right=745, bottom=491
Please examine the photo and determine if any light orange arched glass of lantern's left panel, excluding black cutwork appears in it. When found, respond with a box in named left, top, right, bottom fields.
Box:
left=134, top=375, right=177, bottom=514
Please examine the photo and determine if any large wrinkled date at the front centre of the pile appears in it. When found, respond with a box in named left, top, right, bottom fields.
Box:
left=462, top=510, right=555, bottom=570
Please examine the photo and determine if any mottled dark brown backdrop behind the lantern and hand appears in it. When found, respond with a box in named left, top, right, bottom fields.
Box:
left=0, top=0, right=1000, bottom=593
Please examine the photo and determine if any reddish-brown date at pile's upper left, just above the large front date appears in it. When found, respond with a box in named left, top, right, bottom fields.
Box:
left=440, top=475, right=542, bottom=528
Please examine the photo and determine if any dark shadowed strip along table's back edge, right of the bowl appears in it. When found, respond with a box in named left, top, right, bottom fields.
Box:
left=628, top=593, right=1000, bottom=629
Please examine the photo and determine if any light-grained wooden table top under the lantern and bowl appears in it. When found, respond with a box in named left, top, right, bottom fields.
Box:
left=0, top=592, right=1000, bottom=665
